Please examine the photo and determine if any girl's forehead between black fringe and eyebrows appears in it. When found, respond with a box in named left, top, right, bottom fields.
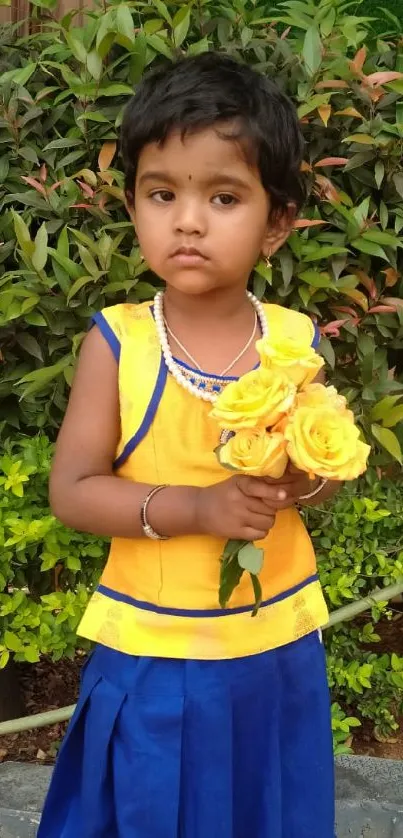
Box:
left=137, top=125, right=260, bottom=183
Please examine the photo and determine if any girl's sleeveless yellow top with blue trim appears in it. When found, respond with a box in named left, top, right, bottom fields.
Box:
left=79, top=303, right=328, bottom=659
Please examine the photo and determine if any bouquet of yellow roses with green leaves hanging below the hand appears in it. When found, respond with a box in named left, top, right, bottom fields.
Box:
left=211, top=335, right=370, bottom=614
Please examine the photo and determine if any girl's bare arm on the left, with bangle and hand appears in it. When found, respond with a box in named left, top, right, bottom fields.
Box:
left=50, top=326, right=274, bottom=540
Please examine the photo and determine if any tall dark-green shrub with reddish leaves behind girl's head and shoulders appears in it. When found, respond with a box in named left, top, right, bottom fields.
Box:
left=0, top=0, right=403, bottom=452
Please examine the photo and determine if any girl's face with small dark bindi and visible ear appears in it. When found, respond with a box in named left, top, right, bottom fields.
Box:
left=131, top=126, right=290, bottom=294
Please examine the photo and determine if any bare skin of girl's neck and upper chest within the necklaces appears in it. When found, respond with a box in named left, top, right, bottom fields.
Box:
left=164, top=288, right=261, bottom=376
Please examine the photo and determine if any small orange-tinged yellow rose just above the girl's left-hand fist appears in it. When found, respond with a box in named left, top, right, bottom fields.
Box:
left=218, top=428, right=288, bottom=480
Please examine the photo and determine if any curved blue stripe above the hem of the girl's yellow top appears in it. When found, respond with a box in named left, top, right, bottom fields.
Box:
left=97, top=573, right=318, bottom=617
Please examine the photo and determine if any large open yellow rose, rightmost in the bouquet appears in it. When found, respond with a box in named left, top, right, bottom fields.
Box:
left=284, top=406, right=370, bottom=480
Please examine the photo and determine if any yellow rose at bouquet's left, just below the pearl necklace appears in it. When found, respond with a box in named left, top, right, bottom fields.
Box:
left=210, top=369, right=296, bottom=431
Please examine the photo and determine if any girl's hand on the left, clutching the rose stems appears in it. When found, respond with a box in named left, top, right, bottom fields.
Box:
left=195, top=475, right=275, bottom=541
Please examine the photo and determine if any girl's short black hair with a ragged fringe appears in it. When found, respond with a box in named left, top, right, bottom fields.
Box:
left=121, top=52, right=305, bottom=214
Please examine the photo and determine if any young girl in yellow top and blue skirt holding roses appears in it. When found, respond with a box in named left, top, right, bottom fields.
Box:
left=39, top=53, right=335, bottom=838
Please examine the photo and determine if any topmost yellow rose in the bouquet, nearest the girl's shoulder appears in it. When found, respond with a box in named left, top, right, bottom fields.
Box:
left=256, top=334, right=325, bottom=387
